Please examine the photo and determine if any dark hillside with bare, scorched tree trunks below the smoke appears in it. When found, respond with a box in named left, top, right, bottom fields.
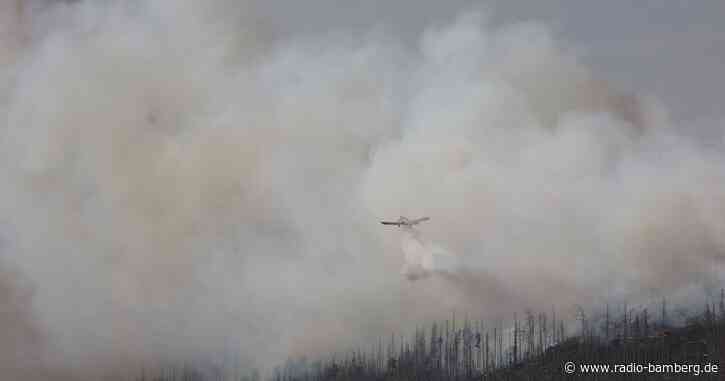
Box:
left=273, top=291, right=725, bottom=381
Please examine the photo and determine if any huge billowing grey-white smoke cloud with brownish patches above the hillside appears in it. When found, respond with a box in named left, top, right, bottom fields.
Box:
left=0, top=0, right=725, bottom=379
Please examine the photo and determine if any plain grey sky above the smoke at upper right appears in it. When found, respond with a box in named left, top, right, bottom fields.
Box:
left=259, top=0, right=725, bottom=119
